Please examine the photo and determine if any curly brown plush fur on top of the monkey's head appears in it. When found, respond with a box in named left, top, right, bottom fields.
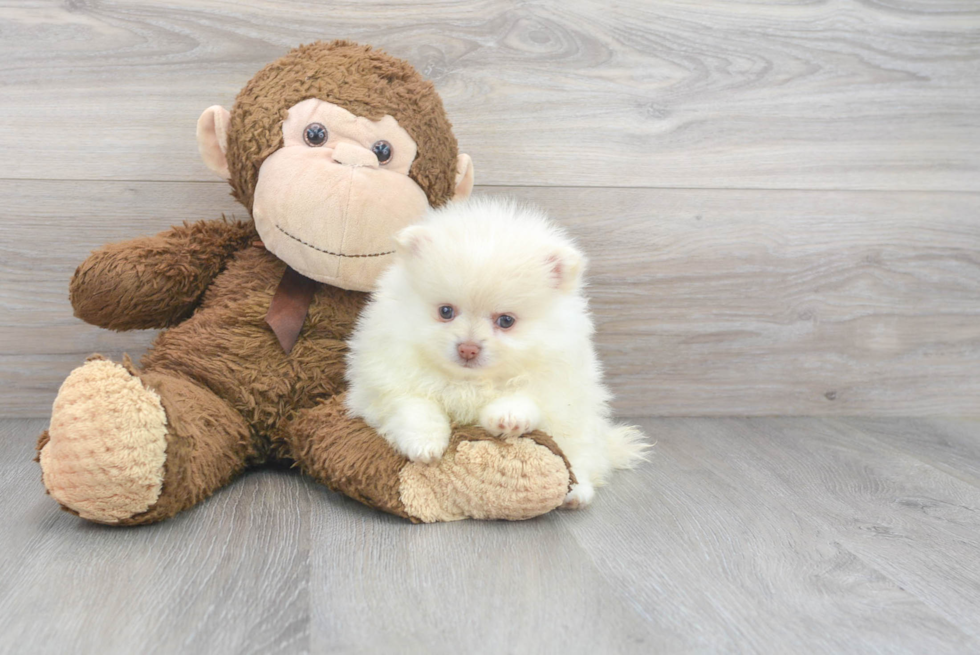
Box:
left=228, top=41, right=458, bottom=211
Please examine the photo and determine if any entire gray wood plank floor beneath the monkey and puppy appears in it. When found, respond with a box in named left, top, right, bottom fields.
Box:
left=0, top=418, right=980, bottom=653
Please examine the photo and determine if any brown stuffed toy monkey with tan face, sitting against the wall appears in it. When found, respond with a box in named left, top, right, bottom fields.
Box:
left=38, top=41, right=572, bottom=525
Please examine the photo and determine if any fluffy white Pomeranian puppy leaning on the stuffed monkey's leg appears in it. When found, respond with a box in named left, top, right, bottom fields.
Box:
left=347, top=199, right=647, bottom=508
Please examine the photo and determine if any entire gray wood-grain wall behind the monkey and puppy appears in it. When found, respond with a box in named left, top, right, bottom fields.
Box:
left=0, top=0, right=980, bottom=417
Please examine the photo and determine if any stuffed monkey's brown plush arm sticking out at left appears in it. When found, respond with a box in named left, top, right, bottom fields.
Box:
left=69, top=220, right=258, bottom=330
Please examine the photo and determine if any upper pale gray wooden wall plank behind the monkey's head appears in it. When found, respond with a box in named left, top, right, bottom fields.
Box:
left=0, top=0, right=980, bottom=191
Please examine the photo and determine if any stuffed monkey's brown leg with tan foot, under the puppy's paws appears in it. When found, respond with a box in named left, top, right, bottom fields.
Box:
left=280, top=396, right=577, bottom=523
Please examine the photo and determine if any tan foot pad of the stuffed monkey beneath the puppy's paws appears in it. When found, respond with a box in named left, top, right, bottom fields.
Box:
left=399, top=437, right=574, bottom=523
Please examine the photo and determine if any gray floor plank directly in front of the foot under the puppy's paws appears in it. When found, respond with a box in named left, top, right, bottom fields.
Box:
left=310, top=492, right=660, bottom=655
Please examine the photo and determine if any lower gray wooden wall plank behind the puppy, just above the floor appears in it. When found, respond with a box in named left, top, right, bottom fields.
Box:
left=0, top=181, right=980, bottom=416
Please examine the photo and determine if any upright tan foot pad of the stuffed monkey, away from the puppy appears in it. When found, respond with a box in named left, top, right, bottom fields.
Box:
left=39, top=358, right=167, bottom=523
